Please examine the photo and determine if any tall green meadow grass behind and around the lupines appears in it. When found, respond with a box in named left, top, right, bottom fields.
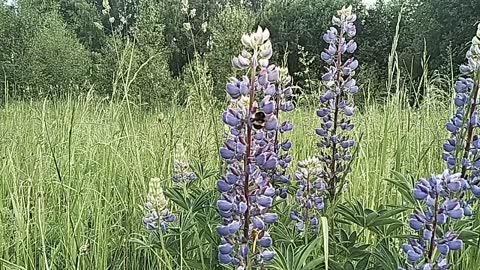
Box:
left=0, top=91, right=476, bottom=269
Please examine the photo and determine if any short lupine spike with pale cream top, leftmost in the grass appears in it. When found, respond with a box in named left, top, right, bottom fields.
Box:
left=143, top=178, right=176, bottom=232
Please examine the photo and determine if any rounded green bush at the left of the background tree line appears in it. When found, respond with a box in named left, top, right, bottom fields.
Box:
left=22, top=14, right=91, bottom=94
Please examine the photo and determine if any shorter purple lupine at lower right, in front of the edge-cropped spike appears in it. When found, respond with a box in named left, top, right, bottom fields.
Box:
left=403, top=170, right=464, bottom=269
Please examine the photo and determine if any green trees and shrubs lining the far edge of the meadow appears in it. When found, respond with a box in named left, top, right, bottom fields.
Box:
left=0, top=0, right=480, bottom=105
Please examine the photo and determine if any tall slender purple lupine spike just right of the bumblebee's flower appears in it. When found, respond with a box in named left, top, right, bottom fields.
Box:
left=315, top=6, right=358, bottom=200
